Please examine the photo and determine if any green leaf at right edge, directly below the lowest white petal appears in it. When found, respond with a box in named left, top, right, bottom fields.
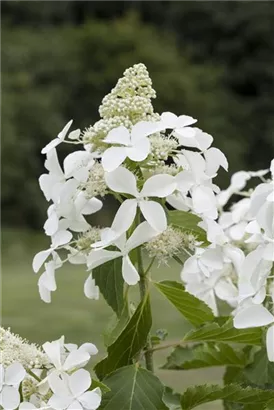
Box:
left=244, top=348, right=274, bottom=388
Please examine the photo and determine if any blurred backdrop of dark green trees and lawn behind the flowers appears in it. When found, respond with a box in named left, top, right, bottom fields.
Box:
left=0, top=0, right=274, bottom=408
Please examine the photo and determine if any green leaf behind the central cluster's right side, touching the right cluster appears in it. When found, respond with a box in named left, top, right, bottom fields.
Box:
left=168, top=211, right=207, bottom=243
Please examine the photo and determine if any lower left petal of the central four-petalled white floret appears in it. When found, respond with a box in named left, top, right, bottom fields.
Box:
left=111, top=199, right=137, bottom=234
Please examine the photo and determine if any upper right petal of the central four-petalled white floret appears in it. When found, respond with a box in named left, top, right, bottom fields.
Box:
left=141, top=174, right=176, bottom=198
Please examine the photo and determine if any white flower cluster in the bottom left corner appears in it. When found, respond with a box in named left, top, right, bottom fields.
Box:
left=0, top=328, right=101, bottom=410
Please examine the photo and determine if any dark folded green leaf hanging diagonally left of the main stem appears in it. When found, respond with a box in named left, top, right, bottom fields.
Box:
left=95, top=296, right=152, bottom=379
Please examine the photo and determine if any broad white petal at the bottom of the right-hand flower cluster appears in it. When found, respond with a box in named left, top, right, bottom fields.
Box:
left=234, top=305, right=274, bottom=329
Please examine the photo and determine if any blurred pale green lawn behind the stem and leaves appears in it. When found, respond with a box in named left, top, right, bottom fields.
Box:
left=1, top=230, right=223, bottom=410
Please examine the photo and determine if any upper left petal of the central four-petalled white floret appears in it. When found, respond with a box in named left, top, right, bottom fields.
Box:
left=105, top=167, right=138, bottom=196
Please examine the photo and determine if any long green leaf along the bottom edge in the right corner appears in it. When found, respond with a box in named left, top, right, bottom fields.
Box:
left=181, top=384, right=274, bottom=410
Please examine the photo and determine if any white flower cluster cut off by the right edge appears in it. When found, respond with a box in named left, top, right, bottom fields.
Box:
left=181, top=160, right=274, bottom=361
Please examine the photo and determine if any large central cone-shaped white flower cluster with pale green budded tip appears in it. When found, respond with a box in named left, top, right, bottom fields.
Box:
left=33, top=64, right=229, bottom=302
